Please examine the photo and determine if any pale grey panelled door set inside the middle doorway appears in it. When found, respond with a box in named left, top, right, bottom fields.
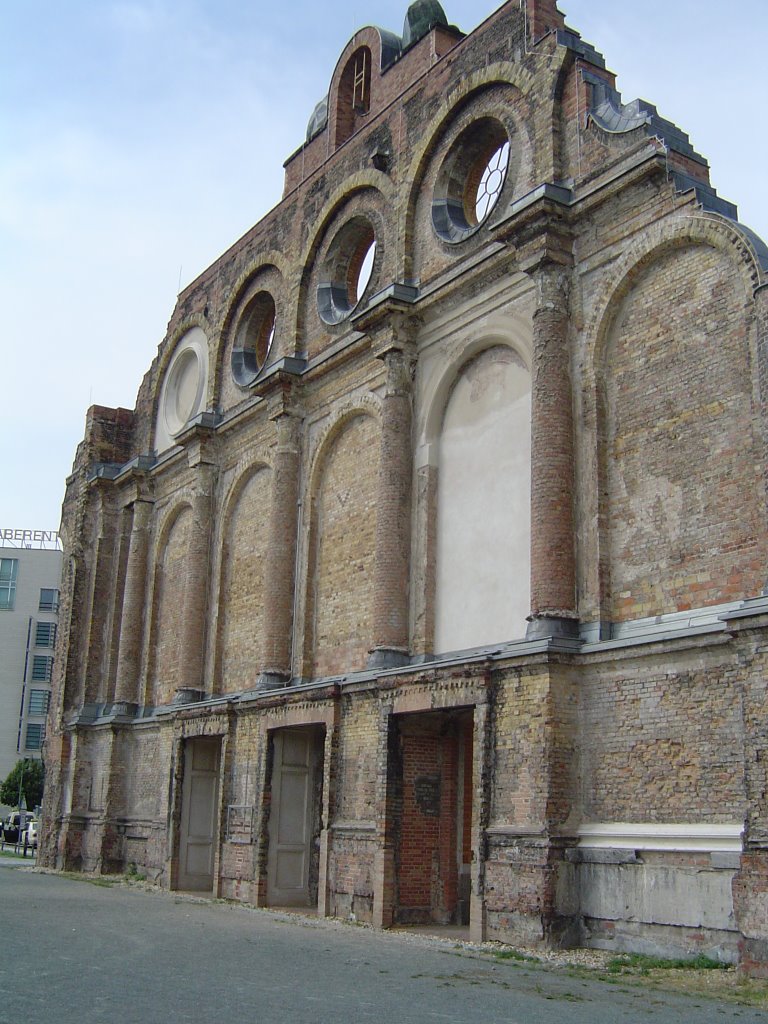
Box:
left=267, top=729, right=317, bottom=906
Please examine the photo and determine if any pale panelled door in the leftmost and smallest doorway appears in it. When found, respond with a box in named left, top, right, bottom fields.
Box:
left=181, top=736, right=221, bottom=892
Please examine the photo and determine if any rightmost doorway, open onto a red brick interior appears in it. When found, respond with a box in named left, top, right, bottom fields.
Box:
left=392, top=710, right=473, bottom=925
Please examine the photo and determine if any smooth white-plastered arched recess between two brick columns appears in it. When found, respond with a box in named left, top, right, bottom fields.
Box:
left=427, top=338, right=530, bottom=653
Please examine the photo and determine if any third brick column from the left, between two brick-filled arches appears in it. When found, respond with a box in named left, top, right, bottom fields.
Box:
left=258, top=410, right=301, bottom=690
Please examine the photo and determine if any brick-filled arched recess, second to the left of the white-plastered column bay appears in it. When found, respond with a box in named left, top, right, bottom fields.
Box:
left=304, top=409, right=380, bottom=678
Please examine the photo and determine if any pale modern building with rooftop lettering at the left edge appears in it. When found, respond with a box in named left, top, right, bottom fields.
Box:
left=0, top=529, right=61, bottom=811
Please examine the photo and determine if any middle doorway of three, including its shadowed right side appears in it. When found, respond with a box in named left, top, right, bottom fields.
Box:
left=266, top=726, right=325, bottom=907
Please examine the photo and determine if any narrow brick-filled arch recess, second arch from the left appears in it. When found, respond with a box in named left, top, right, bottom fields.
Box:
left=214, top=464, right=272, bottom=693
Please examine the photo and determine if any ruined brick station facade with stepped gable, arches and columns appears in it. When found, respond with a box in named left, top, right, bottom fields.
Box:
left=41, top=0, right=768, bottom=974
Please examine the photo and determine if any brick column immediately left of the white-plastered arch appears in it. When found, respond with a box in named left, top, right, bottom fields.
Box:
left=369, top=339, right=413, bottom=669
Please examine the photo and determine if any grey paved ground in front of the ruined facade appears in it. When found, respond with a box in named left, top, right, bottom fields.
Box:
left=0, top=858, right=768, bottom=1024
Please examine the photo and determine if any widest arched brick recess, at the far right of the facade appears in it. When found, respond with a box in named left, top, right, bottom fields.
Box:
left=594, top=234, right=766, bottom=623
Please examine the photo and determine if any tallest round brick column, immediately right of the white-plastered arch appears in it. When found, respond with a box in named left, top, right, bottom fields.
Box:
left=527, top=261, right=578, bottom=639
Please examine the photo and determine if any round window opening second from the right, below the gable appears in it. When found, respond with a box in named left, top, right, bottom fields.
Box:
left=317, top=217, right=376, bottom=324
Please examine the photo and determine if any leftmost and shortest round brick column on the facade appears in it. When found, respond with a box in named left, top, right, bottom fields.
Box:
left=115, top=501, right=153, bottom=713
